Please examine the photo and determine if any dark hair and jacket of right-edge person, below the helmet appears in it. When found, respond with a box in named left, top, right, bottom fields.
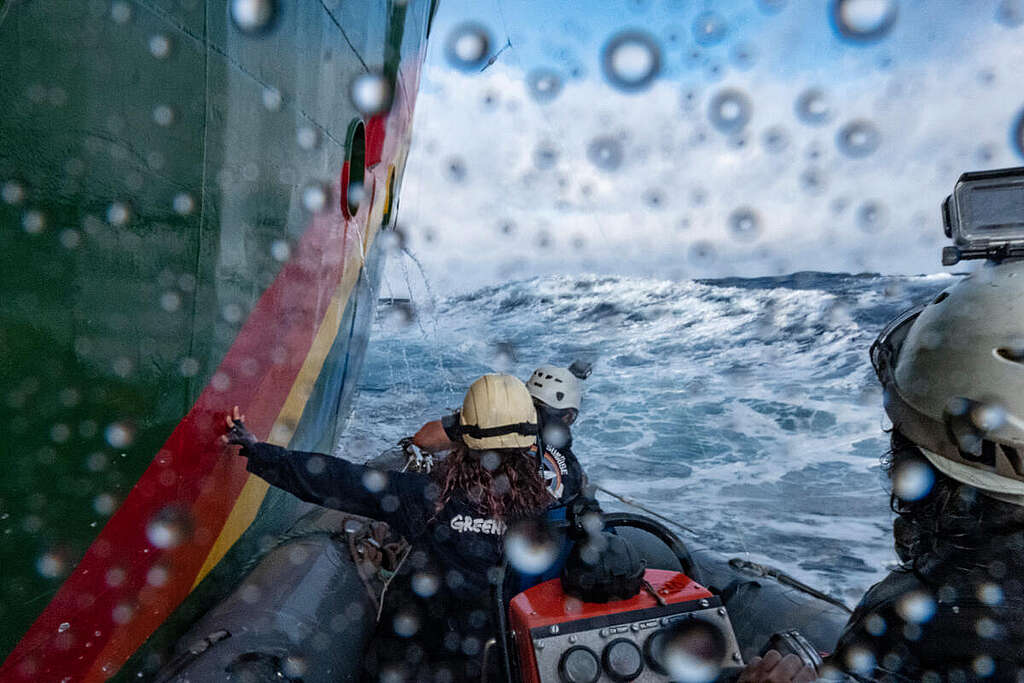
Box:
left=828, top=431, right=1024, bottom=681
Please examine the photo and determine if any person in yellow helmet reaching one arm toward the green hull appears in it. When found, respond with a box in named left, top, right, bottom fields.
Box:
left=225, top=375, right=551, bottom=682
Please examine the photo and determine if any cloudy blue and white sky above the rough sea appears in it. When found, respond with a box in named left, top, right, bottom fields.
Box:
left=384, top=0, right=1024, bottom=297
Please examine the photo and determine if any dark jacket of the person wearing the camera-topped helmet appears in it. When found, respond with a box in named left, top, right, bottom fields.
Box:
left=830, top=535, right=1024, bottom=681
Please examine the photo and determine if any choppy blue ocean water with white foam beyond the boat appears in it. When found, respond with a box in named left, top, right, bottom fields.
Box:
left=338, top=272, right=954, bottom=604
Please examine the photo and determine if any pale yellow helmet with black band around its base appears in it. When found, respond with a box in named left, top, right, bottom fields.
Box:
left=459, top=375, right=538, bottom=451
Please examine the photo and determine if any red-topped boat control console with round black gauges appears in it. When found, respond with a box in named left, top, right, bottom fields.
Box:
left=509, top=569, right=742, bottom=683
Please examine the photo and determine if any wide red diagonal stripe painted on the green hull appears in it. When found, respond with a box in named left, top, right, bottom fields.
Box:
left=0, top=200, right=356, bottom=681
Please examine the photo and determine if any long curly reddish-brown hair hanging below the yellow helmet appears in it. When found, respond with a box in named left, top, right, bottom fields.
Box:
left=434, top=443, right=554, bottom=521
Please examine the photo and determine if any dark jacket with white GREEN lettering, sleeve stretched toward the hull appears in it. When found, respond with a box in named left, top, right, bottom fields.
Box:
left=242, top=443, right=506, bottom=681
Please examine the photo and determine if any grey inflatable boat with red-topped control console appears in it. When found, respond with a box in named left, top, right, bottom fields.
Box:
left=148, top=450, right=849, bottom=683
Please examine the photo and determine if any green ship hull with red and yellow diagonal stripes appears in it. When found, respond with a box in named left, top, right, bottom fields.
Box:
left=0, top=0, right=433, bottom=681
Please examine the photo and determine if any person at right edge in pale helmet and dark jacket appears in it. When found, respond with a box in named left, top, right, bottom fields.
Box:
left=828, top=260, right=1024, bottom=682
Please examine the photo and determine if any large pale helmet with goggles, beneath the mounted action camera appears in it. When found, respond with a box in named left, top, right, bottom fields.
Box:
left=871, top=261, right=1024, bottom=505
